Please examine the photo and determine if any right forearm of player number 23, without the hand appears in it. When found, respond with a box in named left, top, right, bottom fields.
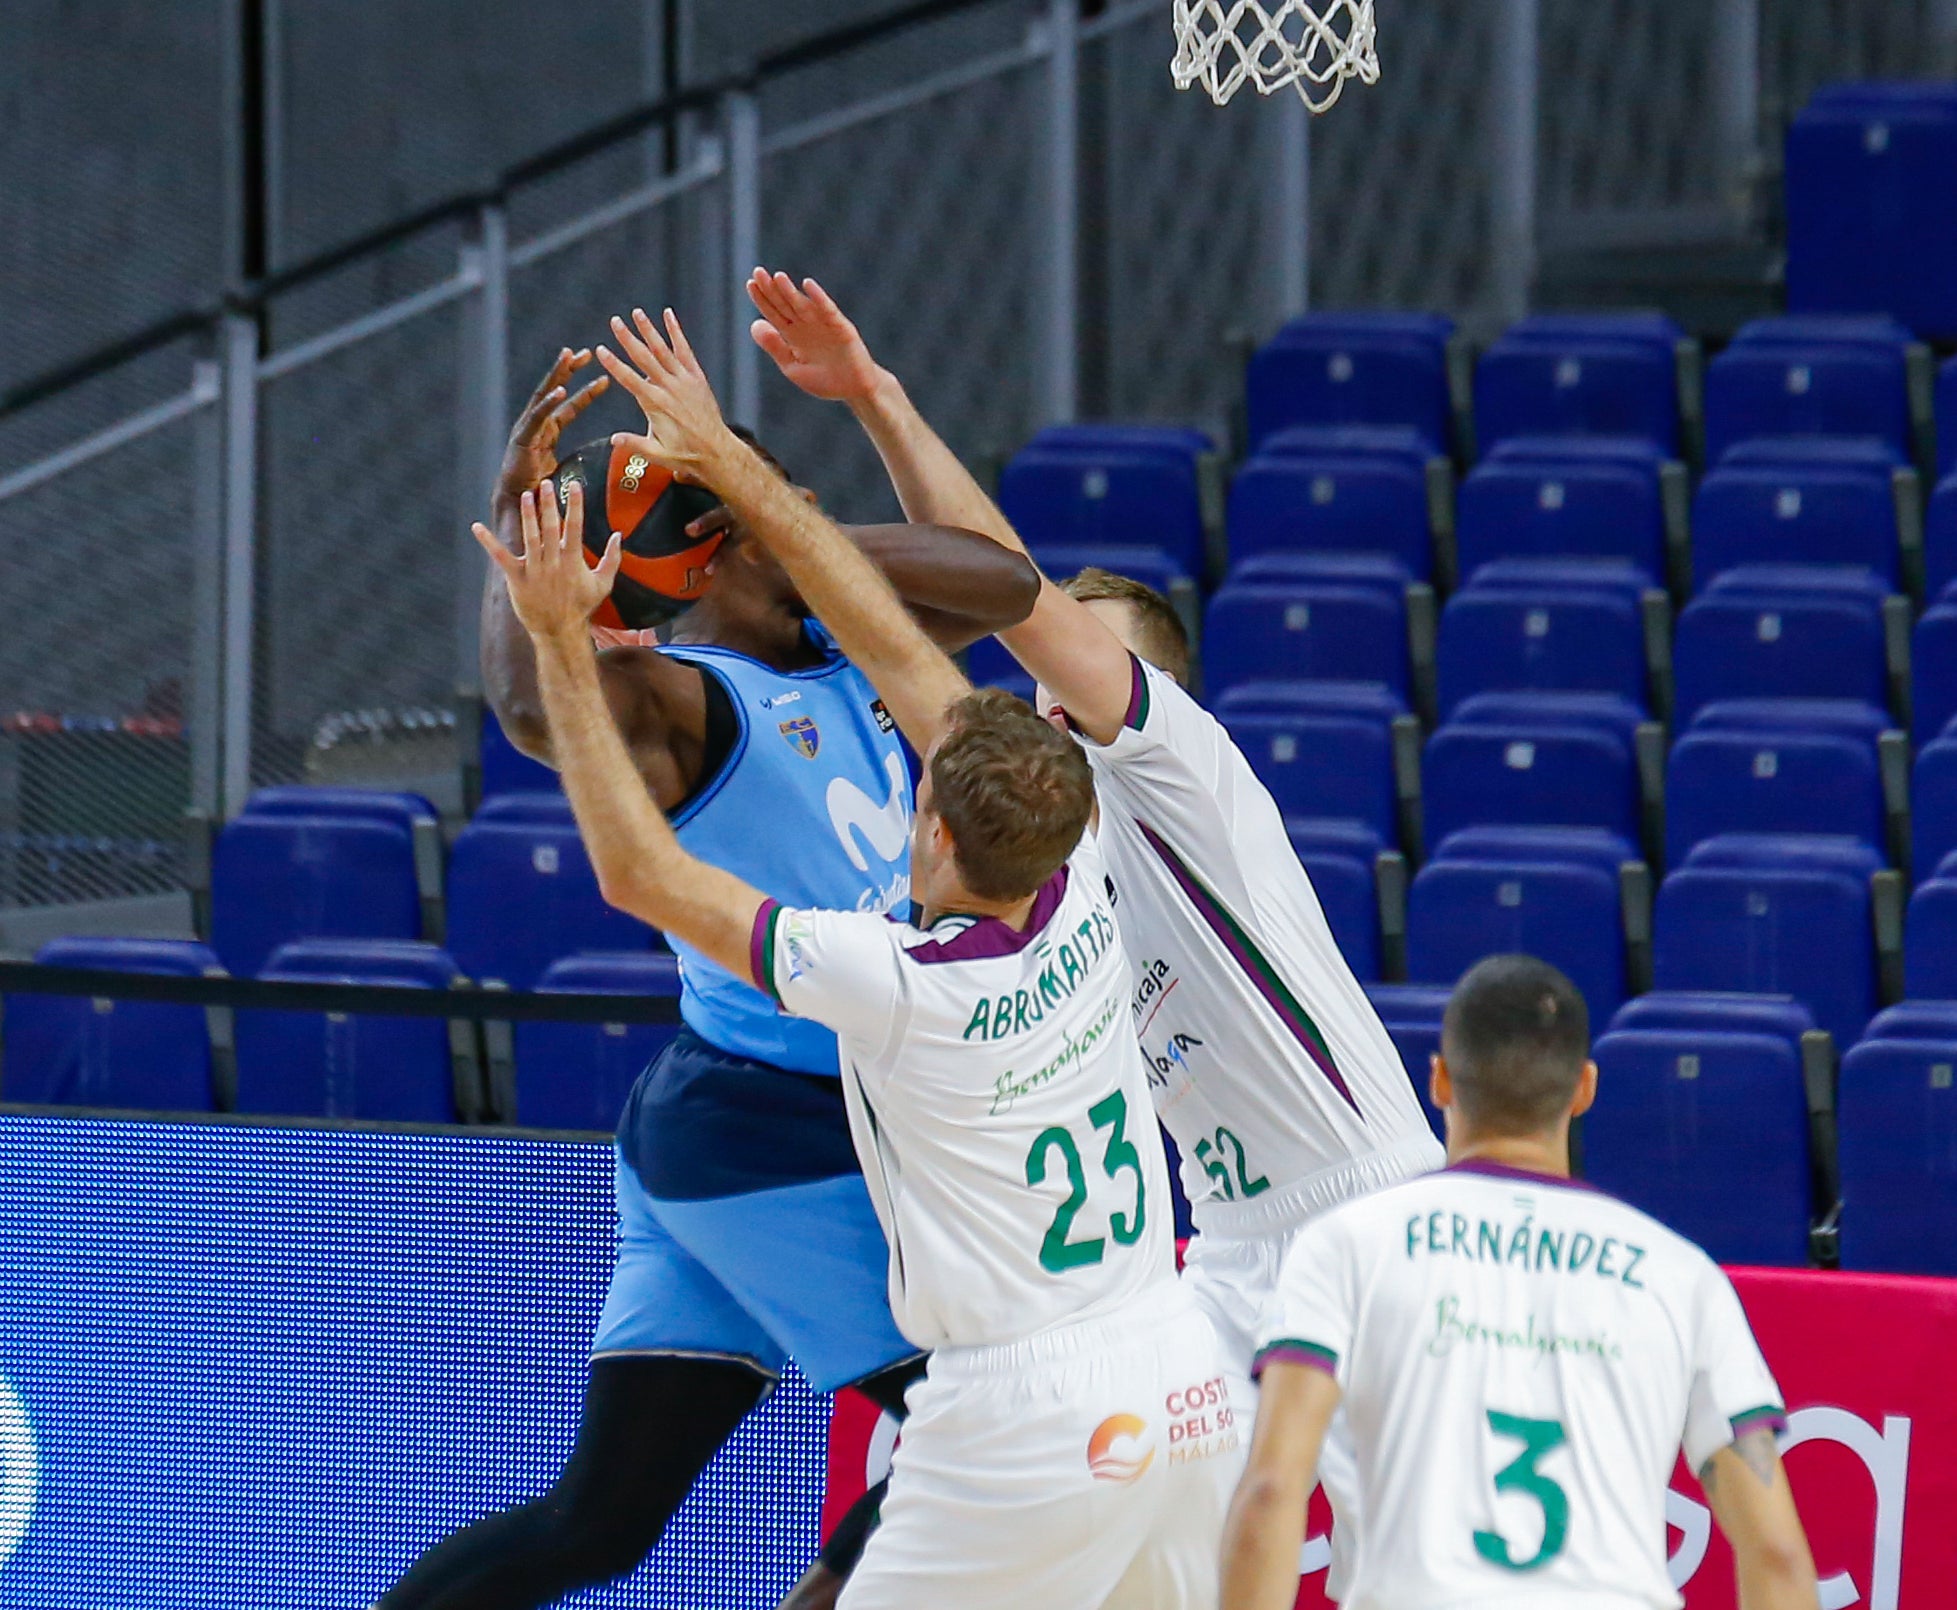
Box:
left=712, top=438, right=971, bottom=753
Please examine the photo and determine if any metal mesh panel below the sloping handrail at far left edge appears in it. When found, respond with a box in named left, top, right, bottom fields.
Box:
left=0, top=403, right=211, bottom=906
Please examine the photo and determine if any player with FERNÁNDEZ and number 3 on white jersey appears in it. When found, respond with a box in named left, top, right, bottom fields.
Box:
left=1223, top=957, right=1818, bottom=1610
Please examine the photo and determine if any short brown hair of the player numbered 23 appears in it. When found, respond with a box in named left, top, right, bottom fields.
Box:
left=932, top=689, right=1094, bottom=900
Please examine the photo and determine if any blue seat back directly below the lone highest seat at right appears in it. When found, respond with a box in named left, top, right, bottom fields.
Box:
left=1707, top=342, right=1910, bottom=464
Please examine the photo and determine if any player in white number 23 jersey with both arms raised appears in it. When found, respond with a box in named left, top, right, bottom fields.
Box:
left=476, top=313, right=1241, bottom=1610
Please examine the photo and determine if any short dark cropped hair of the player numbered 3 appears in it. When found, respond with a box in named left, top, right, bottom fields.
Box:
left=1440, top=957, right=1589, bottom=1135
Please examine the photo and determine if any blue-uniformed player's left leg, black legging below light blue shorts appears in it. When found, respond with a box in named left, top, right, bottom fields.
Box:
left=380, top=1160, right=783, bottom=1610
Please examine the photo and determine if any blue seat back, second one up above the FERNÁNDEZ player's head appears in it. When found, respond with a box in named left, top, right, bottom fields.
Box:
left=1421, top=724, right=1638, bottom=843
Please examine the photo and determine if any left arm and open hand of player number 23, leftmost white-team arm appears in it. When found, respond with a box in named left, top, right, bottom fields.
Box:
left=476, top=481, right=761, bottom=978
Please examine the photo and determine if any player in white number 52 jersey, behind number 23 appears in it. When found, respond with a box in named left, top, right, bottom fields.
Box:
left=748, top=270, right=1440, bottom=1416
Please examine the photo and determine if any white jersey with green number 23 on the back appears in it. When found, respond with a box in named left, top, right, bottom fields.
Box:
left=755, top=837, right=1174, bottom=1348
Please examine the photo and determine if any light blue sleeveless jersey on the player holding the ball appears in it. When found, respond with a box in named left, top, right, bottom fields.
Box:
left=661, top=622, right=914, bottom=1074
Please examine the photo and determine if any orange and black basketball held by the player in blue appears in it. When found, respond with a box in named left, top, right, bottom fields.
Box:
left=558, top=440, right=726, bottom=632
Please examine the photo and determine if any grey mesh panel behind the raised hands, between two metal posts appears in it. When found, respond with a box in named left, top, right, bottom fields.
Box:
left=751, top=45, right=1043, bottom=520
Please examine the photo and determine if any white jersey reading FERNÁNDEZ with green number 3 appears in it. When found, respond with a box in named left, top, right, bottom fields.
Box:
left=1258, top=1162, right=1783, bottom=1610
